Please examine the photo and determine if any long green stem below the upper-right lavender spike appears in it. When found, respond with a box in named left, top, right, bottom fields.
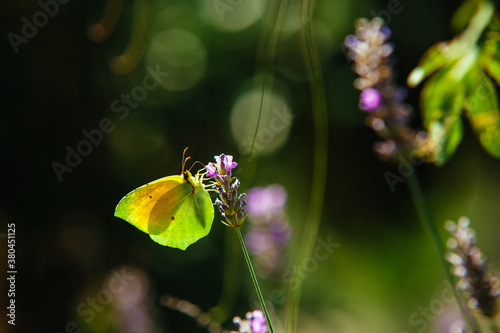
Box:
left=408, top=171, right=479, bottom=333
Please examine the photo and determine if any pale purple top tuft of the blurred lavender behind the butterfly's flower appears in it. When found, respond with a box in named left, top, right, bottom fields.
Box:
left=248, top=184, right=287, bottom=216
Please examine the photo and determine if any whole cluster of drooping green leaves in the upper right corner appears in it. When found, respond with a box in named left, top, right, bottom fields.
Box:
left=408, top=0, right=500, bottom=166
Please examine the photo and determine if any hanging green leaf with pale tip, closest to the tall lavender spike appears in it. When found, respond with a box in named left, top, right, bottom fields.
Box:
left=420, top=67, right=466, bottom=166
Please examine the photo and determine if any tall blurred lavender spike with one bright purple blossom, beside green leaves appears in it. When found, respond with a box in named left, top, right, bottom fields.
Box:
left=345, top=17, right=427, bottom=161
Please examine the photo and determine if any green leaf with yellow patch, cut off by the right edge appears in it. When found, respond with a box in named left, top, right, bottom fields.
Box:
left=464, top=67, right=500, bottom=158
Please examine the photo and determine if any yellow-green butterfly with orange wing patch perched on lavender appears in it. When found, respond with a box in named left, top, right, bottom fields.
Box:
left=115, top=148, right=214, bottom=250
